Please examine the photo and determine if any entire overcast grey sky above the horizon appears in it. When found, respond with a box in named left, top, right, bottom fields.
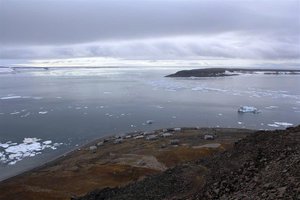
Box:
left=0, top=0, right=300, bottom=67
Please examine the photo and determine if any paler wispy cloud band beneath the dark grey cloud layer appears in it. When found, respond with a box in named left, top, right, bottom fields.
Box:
left=0, top=32, right=300, bottom=60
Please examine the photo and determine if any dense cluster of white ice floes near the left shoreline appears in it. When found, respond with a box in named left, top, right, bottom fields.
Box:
left=0, top=138, right=63, bottom=165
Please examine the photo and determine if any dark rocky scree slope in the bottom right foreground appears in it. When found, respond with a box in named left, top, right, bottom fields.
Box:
left=72, top=126, right=300, bottom=200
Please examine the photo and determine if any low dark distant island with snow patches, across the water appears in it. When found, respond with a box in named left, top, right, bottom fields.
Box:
left=166, top=68, right=300, bottom=77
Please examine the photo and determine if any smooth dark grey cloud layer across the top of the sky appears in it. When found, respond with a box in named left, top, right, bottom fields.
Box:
left=0, top=0, right=300, bottom=45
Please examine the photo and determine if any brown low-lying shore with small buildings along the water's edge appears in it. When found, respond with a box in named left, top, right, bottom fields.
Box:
left=0, top=128, right=255, bottom=200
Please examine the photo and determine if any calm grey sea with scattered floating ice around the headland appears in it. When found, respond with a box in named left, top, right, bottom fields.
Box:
left=0, top=68, right=300, bottom=180
